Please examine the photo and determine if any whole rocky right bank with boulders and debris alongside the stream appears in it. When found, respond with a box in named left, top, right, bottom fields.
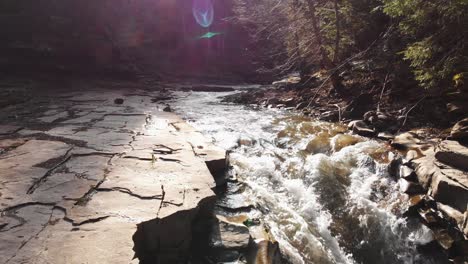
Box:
left=220, top=84, right=468, bottom=263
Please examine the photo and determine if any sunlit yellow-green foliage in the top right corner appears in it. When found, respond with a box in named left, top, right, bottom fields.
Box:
left=383, top=0, right=468, bottom=88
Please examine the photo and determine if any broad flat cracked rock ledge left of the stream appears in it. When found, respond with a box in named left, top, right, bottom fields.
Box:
left=0, top=88, right=226, bottom=264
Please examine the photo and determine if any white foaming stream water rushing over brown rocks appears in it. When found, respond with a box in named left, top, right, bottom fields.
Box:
left=170, top=89, right=444, bottom=264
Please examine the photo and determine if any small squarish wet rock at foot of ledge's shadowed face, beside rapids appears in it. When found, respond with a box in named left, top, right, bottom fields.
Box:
left=210, top=215, right=250, bottom=251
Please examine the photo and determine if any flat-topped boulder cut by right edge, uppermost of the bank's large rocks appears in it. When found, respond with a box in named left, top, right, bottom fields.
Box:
left=435, top=140, right=468, bottom=171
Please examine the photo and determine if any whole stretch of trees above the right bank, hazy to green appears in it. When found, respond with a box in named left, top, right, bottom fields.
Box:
left=235, top=0, right=468, bottom=92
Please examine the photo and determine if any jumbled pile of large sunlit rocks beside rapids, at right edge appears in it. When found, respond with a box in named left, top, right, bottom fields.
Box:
left=392, top=132, right=468, bottom=257
